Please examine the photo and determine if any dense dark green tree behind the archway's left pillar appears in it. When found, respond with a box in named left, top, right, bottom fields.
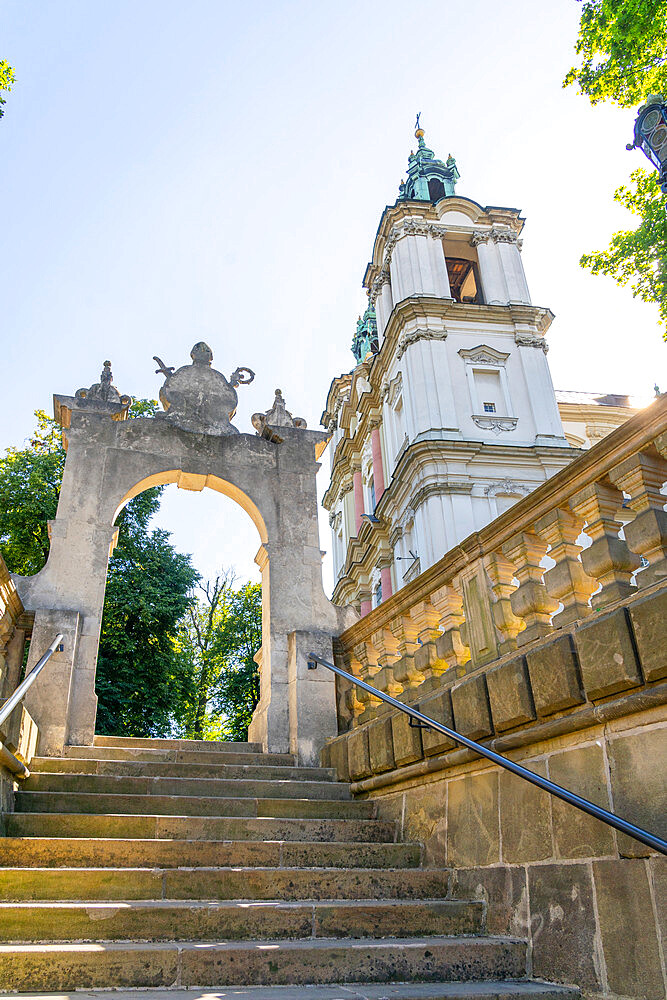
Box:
left=0, top=400, right=198, bottom=736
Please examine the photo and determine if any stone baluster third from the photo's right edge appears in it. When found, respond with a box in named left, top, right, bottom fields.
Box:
left=534, top=507, right=597, bottom=627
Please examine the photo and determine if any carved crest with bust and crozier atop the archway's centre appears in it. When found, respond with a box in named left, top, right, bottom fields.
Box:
left=154, top=341, right=255, bottom=436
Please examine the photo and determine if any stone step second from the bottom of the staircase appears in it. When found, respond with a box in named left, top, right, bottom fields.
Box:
left=0, top=937, right=526, bottom=990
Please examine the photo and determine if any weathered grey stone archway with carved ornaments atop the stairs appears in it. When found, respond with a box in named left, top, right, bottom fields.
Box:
left=16, top=344, right=349, bottom=763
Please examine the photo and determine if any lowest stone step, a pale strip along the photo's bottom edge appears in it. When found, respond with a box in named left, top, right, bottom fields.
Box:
left=0, top=979, right=581, bottom=1000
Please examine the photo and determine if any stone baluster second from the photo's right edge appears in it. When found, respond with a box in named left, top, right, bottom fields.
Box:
left=570, top=479, right=640, bottom=610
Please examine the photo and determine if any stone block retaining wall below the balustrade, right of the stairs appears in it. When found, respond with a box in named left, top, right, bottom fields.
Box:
left=323, top=586, right=667, bottom=1000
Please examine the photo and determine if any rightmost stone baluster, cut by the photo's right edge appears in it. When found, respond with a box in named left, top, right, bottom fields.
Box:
left=609, top=449, right=667, bottom=587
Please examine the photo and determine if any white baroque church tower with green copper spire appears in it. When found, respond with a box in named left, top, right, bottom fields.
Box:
left=322, top=121, right=576, bottom=614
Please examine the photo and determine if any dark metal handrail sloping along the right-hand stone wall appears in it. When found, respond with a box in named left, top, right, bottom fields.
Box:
left=308, top=653, right=667, bottom=855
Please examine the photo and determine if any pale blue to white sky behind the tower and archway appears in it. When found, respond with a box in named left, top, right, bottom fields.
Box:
left=0, top=0, right=667, bottom=588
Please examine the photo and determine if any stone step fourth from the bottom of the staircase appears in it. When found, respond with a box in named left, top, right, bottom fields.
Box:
left=0, top=866, right=449, bottom=905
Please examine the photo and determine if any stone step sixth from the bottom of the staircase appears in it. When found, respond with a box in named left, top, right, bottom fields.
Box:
left=3, top=812, right=396, bottom=843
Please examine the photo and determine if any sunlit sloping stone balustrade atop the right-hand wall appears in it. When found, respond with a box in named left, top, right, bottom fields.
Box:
left=336, top=386, right=667, bottom=739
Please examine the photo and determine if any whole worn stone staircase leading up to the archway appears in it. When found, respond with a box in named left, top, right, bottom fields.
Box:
left=0, top=737, right=578, bottom=1000
